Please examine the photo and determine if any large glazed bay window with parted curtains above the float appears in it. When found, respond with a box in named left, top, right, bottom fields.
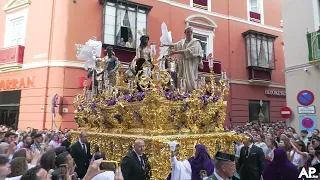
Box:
left=103, top=0, right=152, bottom=48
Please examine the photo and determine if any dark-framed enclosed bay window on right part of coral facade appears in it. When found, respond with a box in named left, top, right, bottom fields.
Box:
left=243, top=30, right=277, bottom=69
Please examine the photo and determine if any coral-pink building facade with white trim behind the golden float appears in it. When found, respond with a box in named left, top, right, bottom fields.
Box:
left=0, top=0, right=286, bottom=129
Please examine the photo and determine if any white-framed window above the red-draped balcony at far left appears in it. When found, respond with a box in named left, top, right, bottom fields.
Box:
left=11, top=17, right=24, bottom=46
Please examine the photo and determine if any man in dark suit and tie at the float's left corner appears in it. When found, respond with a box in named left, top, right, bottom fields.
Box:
left=70, top=132, right=92, bottom=178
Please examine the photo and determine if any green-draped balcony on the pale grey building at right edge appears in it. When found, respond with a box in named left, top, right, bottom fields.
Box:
left=307, top=29, right=320, bottom=67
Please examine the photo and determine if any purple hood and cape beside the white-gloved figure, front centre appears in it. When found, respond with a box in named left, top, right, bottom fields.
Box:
left=188, top=144, right=214, bottom=180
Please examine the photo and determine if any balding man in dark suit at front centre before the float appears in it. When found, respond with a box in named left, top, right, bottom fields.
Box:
left=121, top=139, right=150, bottom=180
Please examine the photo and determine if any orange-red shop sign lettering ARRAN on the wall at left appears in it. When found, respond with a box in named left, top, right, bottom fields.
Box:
left=0, top=77, right=34, bottom=91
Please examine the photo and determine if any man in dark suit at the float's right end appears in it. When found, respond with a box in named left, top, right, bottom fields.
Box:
left=237, top=134, right=265, bottom=180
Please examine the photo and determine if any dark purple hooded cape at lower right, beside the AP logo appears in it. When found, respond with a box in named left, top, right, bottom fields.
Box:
left=263, top=148, right=299, bottom=180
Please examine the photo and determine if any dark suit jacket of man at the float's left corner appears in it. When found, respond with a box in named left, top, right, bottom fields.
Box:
left=70, top=141, right=92, bottom=178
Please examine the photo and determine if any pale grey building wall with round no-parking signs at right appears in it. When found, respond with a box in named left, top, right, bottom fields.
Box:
left=282, top=0, right=320, bottom=131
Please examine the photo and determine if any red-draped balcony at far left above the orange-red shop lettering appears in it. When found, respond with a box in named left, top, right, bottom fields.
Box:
left=0, top=46, right=24, bottom=71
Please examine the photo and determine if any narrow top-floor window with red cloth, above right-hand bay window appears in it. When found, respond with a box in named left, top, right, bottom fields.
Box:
left=248, top=0, right=263, bottom=24
